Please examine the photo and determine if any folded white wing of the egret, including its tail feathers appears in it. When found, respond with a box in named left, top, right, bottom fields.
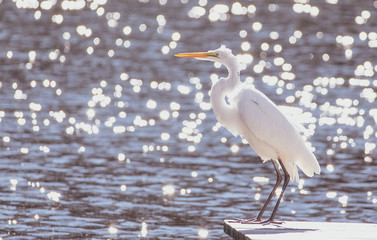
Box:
left=237, top=89, right=320, bottom=180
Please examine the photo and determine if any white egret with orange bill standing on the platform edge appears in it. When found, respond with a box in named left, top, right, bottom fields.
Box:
left=175, top=46, right=320, bottom=224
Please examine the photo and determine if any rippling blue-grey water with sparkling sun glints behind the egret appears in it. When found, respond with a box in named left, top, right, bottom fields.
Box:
left=0, top=0, right=377, bottom=239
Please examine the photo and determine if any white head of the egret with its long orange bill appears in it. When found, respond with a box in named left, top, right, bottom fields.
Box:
left=175, top=45, right=237, bottom=66
